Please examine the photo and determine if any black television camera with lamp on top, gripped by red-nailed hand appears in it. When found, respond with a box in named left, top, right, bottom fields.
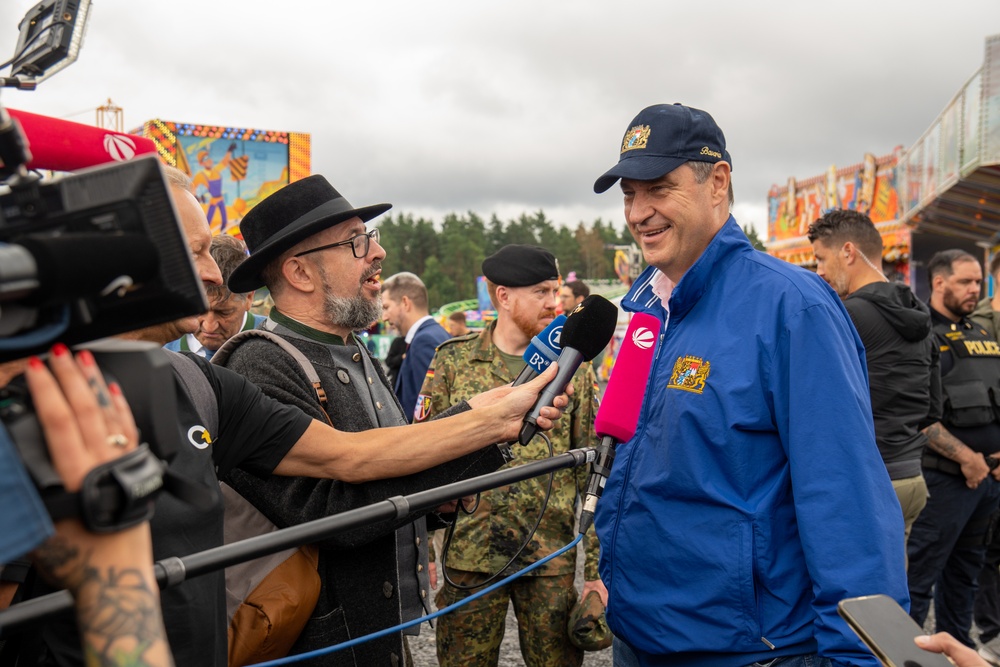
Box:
left=0, top=0, right=208, bottom=531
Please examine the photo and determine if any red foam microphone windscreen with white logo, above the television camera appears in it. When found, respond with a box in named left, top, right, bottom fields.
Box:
left=7, top=109, right=156, bottom=171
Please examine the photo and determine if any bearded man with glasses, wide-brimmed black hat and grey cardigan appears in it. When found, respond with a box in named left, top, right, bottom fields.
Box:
left=216, top=175, right=568, bottom=665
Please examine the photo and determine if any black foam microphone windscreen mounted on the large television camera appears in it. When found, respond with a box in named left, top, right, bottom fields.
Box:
left=13, top=233, right=160, bottom=303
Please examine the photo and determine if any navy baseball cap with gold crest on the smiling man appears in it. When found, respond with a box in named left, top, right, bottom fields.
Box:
left=594, top=102, right=733, bottom=193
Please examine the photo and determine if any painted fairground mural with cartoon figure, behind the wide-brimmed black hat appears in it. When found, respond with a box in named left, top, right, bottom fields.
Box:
left=142, top=120, right=310, bottom=236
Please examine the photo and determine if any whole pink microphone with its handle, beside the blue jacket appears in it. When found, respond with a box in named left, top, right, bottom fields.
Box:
left=580, top=313, right=661, bottom=533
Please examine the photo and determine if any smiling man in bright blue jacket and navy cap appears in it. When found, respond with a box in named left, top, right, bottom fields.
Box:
left=594, top=100, right=908, bottom=667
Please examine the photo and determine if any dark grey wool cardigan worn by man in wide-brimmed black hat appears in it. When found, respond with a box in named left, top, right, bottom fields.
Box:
left=219, top=329, right=504, bottom=667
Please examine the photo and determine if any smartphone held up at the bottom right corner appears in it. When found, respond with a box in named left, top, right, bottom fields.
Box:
left=837, top=595, right=954, bottom=667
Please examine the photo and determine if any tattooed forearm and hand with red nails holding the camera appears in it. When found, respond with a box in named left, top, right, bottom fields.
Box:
left=25, top=345, right=173, bottom=665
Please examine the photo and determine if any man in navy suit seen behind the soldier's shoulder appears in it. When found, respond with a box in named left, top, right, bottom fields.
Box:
left=382, top=271, right=451, bottom=422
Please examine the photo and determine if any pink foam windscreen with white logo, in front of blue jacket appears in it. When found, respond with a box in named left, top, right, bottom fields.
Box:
left=596, top=313, right=660, bottom=442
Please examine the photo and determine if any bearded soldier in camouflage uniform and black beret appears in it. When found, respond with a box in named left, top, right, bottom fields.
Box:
left=417, top=245, right=607, bottom=667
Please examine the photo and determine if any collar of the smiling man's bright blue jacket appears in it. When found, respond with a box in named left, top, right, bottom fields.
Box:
left=622, top=215, right=753, bottom=320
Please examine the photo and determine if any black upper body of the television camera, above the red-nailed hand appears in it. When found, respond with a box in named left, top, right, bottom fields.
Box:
left=0, top=156, right=208, bottom=362
